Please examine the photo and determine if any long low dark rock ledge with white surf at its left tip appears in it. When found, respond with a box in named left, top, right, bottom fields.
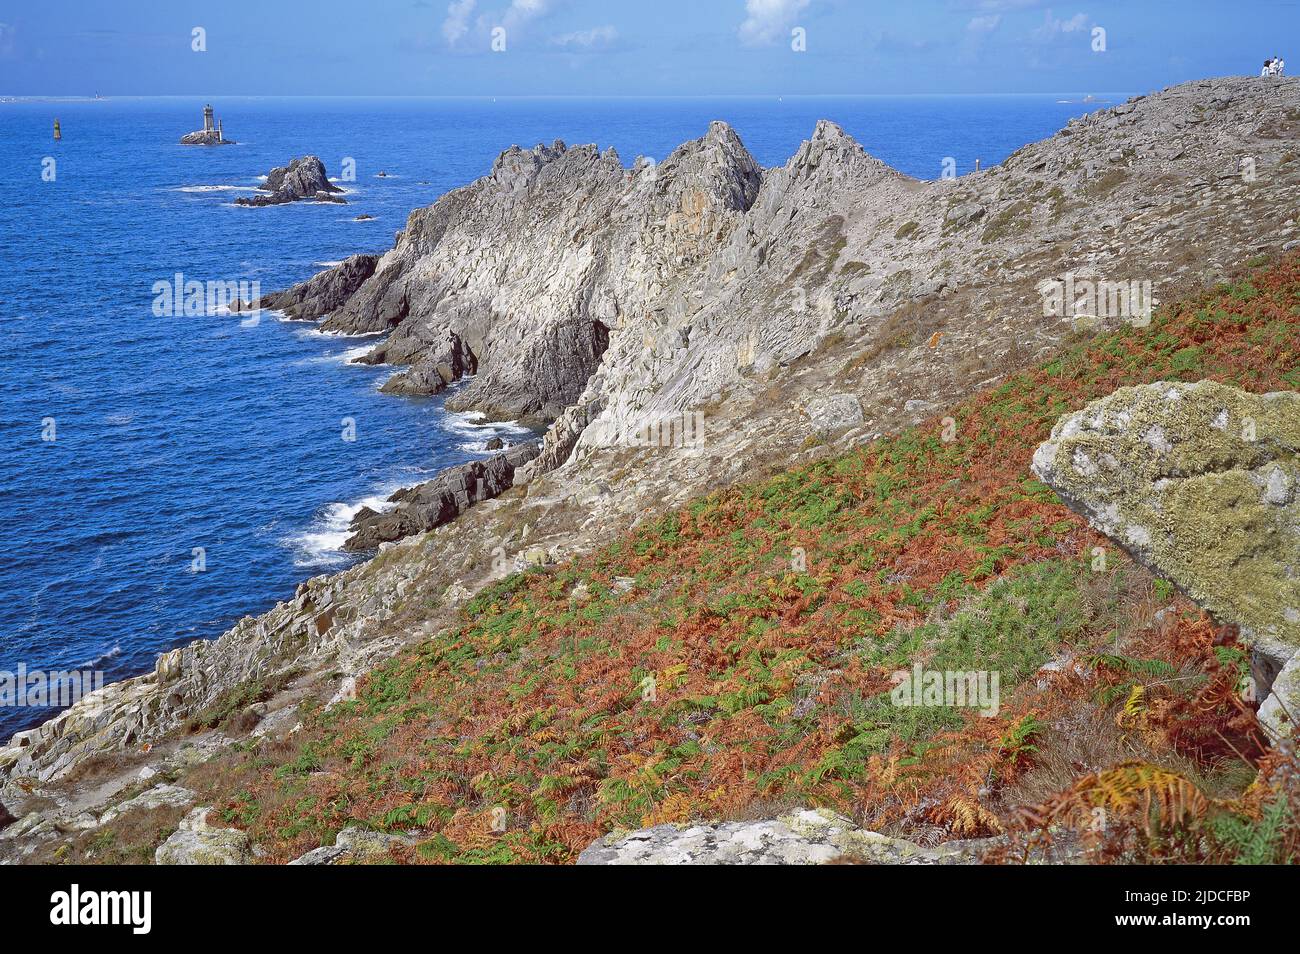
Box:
left=343, top=442, right=538, bottom=551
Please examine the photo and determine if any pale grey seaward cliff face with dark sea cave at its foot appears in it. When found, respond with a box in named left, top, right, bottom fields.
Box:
left=267, top=123, right=762, bottom=422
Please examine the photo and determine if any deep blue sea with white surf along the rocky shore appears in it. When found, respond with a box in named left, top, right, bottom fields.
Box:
left=0, top=96, right=1123, bottom=737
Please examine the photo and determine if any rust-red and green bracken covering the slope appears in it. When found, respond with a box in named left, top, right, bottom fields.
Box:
left=185, top=257, right=1300, bottom=863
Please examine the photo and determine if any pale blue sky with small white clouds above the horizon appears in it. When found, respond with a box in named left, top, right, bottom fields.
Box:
left=0, top=0, right=1300, bottom=96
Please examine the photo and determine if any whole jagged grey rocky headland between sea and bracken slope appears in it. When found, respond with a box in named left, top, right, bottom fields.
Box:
left=0, top=79, right=1300, bottom=868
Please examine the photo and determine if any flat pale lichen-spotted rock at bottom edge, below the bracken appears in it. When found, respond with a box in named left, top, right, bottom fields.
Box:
left=577, top=808, right=989, bottom=864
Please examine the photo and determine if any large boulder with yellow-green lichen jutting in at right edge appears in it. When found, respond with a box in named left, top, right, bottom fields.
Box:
left=1032, top=381, right=1300, bottom=682
